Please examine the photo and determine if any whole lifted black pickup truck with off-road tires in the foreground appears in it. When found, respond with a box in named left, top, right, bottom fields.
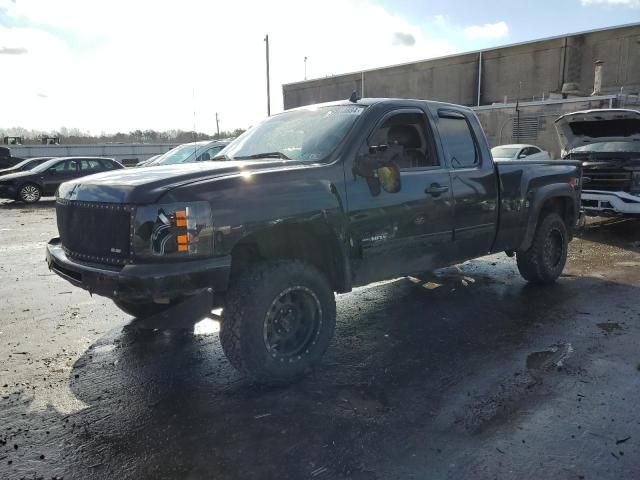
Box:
left=47, top=99, right=581, bottom=383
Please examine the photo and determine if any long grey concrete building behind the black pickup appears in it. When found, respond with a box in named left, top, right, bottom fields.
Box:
left=282, top=23, right=640, bottom=157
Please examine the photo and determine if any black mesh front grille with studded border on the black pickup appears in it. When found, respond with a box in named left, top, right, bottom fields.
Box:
left=56, top=199, right=133, bottom=265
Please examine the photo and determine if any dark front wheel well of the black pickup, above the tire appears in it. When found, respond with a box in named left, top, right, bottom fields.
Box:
left=231, top=225, right=349, bottom=292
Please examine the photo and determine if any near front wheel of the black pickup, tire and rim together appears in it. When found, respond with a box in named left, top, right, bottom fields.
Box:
left=220, top=260, right=336, bottom=384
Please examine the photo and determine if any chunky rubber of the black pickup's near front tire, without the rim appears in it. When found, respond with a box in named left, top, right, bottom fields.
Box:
left=220, top=260, right=336, bottom=385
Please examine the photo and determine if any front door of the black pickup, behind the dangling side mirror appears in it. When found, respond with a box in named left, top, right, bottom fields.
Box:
left=347, top=109, right=453, bottom=285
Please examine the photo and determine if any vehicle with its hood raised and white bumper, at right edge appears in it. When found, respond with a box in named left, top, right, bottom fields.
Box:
left=555, top=109, right=640, bottom=216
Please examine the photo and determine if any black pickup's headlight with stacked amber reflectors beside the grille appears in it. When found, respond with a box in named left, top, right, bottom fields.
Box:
left=133, top=202, right=213, bottom=258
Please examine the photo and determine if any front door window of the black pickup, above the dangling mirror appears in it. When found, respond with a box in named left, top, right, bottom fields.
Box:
left=367, top=112, right=439, bottom=169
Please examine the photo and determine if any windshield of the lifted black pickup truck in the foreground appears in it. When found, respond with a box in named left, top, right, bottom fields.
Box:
left=221, top=105, right=364, bottom=162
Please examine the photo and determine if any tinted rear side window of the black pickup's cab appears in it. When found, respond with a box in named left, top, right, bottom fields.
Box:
left=438, top=112, right=480, bottom=168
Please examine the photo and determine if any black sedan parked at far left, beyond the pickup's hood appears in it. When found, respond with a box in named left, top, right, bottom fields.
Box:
left=0, top=157, right=124, bottom=203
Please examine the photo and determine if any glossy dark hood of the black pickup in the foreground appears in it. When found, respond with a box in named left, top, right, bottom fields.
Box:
left=58, top=159, right=312, bottom=204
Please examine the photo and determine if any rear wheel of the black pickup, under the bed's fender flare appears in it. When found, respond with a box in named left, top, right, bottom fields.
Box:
left=517, top=212, right=569, bottom=285
